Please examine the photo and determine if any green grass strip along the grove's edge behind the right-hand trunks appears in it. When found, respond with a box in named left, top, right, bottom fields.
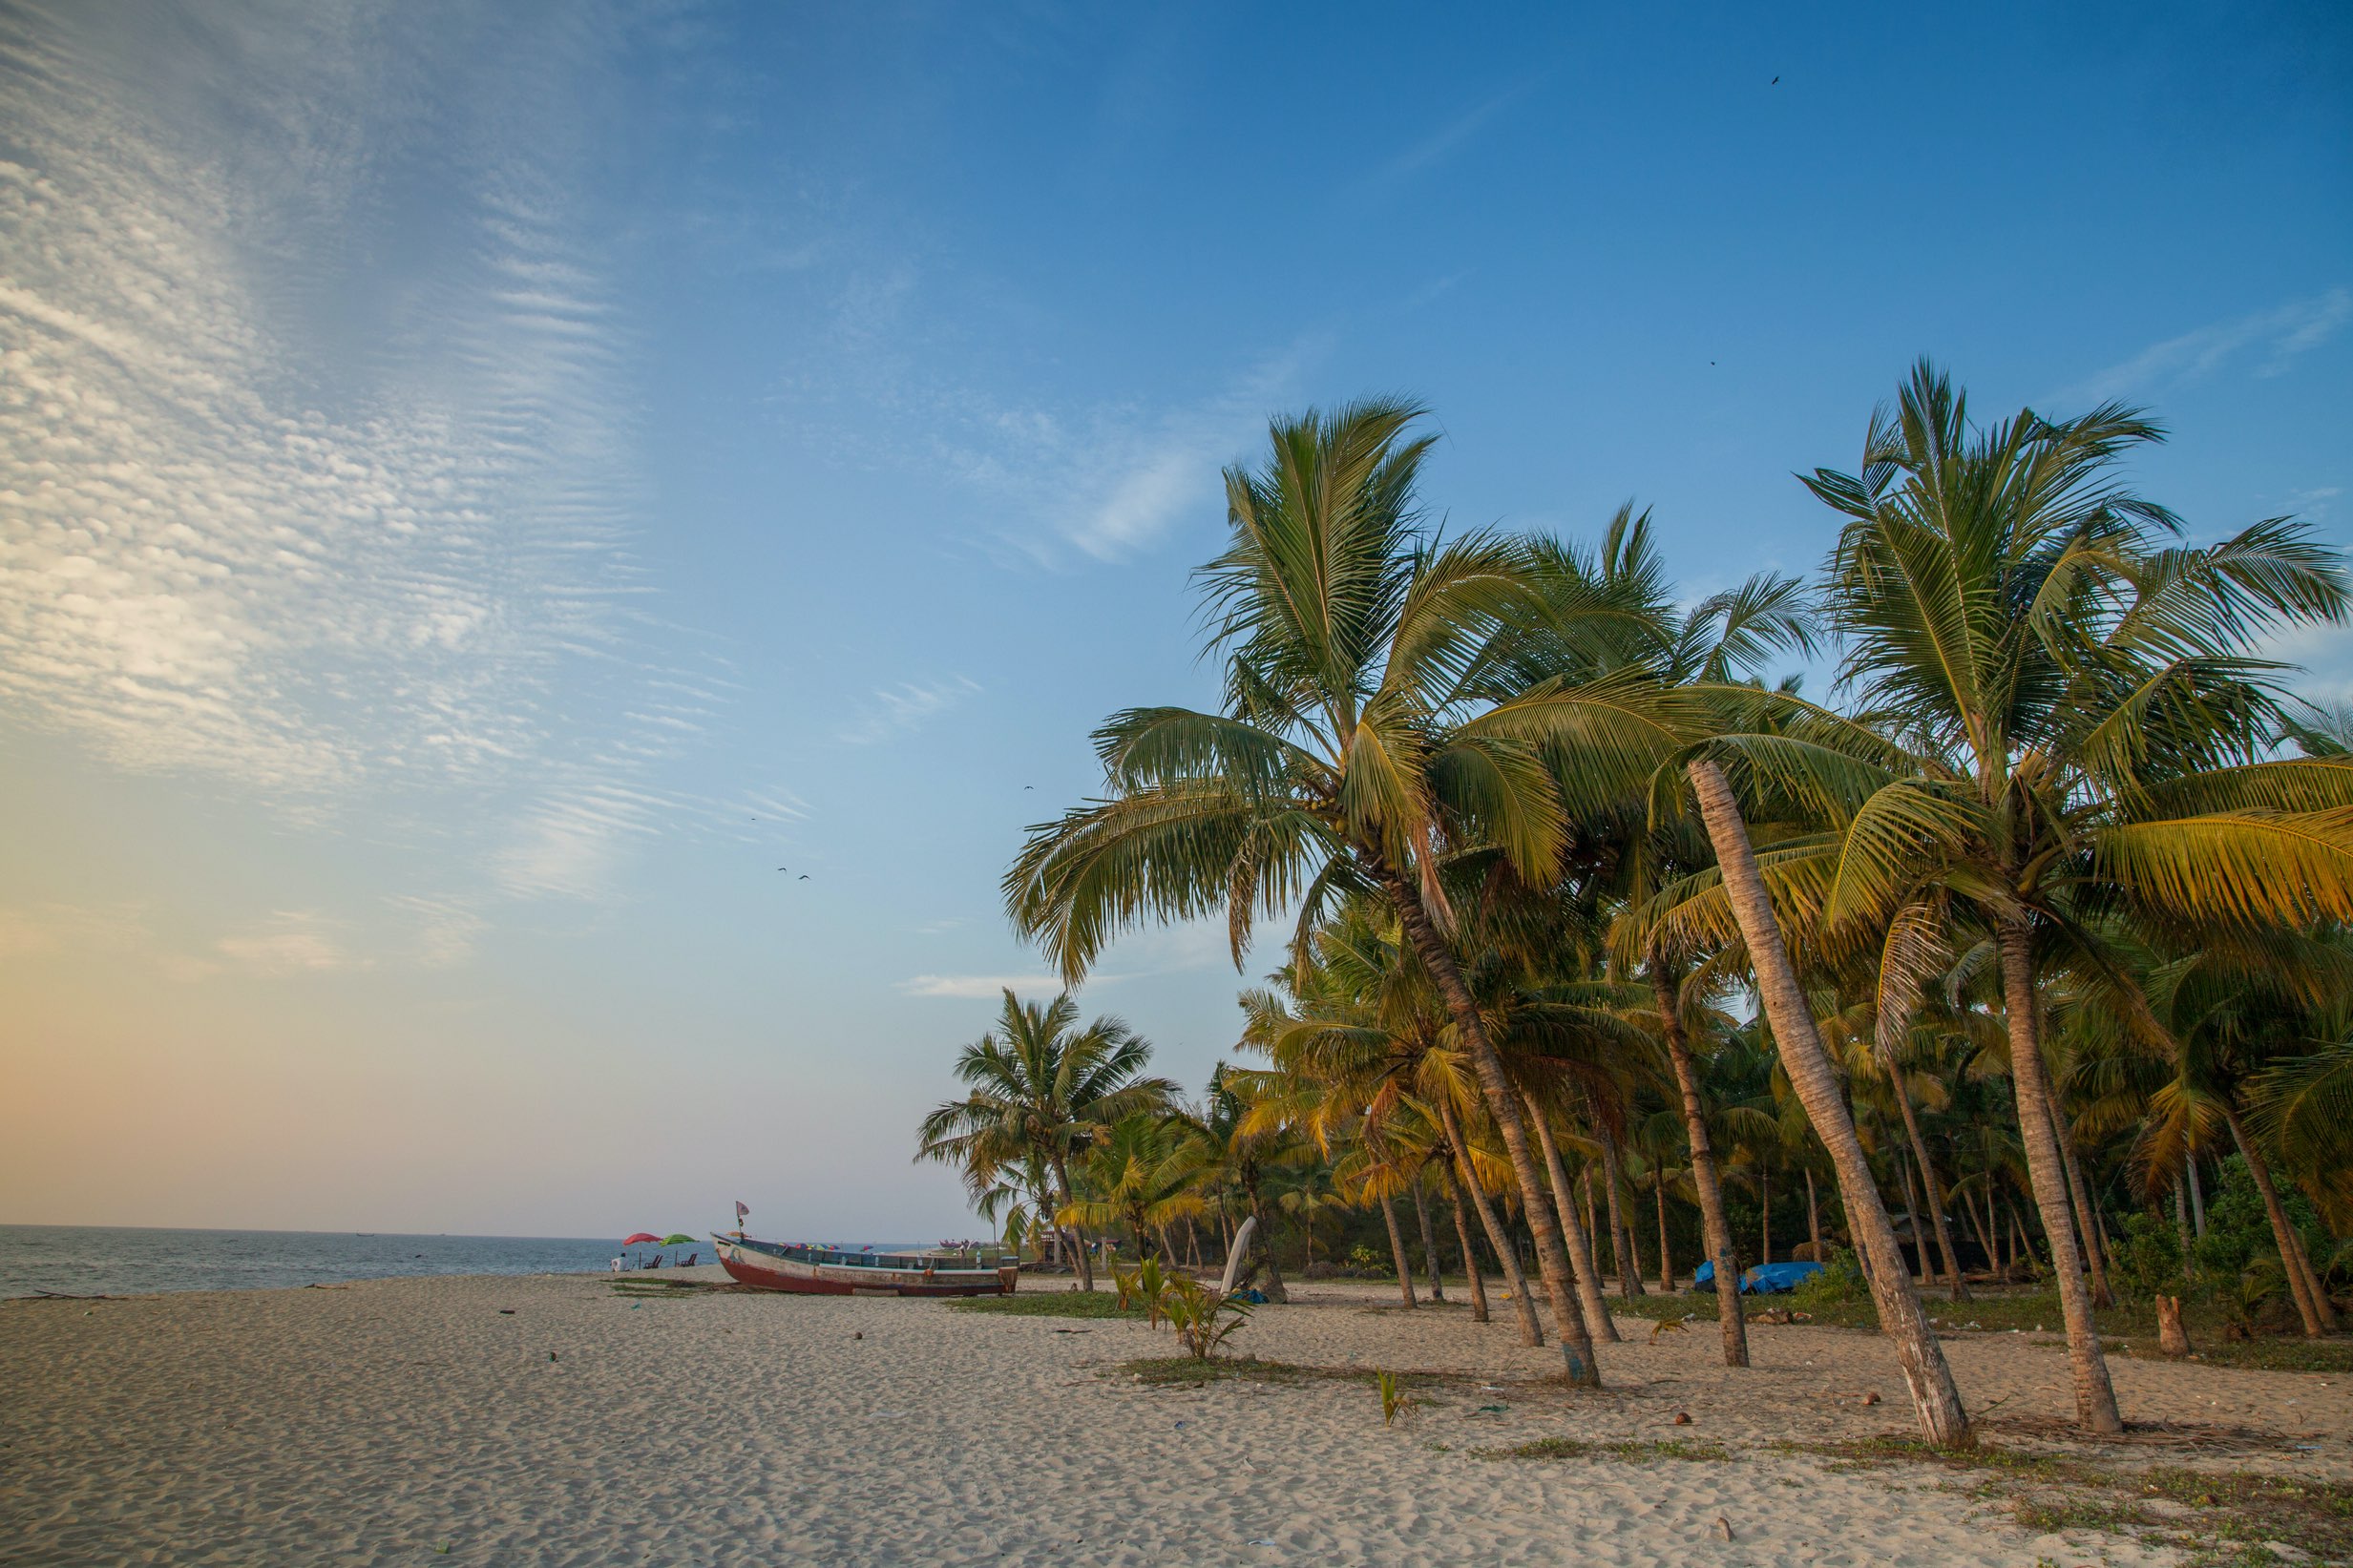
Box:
left=1609, top=1286, right=2353, bottom=1375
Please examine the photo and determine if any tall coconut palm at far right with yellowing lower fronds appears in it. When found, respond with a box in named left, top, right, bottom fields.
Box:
left=1783, top=362, right=2353, bottom=1432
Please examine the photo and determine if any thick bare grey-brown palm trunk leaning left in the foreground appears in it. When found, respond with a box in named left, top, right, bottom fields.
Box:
left=1687, top=760, right=1972, bottom=1448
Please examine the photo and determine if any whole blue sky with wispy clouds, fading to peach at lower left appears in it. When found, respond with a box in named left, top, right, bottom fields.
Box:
left=0, top=2, right=2353, bottom=1237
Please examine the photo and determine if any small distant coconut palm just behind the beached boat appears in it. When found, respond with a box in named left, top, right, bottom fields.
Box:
left=915, top=988, right=1177, bottom=1290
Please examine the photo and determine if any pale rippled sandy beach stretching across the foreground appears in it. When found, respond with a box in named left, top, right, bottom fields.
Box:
left=0, top=1277, right=2353, bottom=1568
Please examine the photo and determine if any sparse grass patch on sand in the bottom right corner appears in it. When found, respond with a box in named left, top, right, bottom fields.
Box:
left=1775, top=1439, right=2353, bottom=1568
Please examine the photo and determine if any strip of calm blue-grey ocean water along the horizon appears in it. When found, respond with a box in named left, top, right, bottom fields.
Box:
left=0, top=1224, right=663, bottom=1295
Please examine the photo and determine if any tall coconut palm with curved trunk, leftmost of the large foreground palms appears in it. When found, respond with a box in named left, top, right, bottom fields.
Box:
left=1005, top=400, right=1685, bottom=1385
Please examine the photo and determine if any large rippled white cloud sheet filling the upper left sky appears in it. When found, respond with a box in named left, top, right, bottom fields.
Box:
left=0, top=5, right=725, bottom=896
